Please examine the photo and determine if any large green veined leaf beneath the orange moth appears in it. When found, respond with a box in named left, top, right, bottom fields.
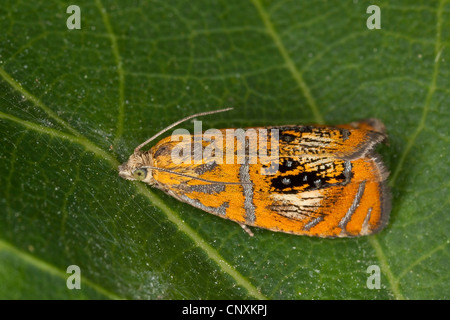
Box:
left=0, top=0, right=450, bottom=299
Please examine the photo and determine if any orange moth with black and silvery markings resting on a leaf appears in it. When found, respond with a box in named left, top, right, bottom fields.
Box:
left=119, top=108, right=391, bottom=238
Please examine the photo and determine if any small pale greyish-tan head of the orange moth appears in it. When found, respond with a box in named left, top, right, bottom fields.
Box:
left=119, top=152, right=153, bottom=184
